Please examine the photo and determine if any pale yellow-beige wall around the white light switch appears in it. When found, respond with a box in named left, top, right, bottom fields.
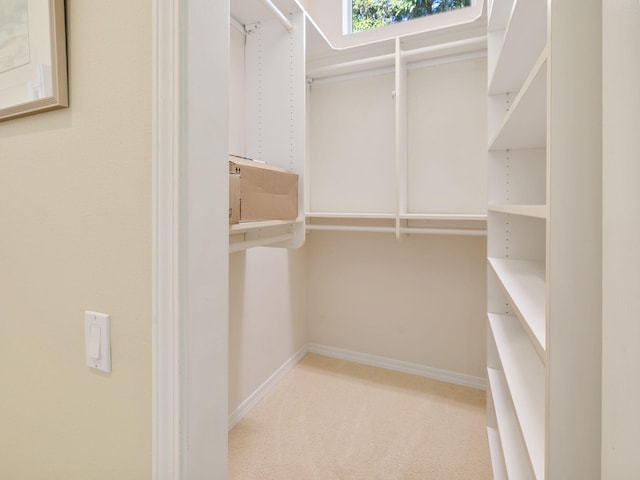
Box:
left=0, top=0, right=152, bottom=480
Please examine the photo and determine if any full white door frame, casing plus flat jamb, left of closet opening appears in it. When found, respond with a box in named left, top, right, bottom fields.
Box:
left=152, top=0, right=229, bottom=480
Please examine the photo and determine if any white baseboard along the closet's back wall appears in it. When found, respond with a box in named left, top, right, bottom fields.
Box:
left=307, top=343, right=487, bottom=390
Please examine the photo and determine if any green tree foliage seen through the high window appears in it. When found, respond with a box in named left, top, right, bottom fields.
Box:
left=351, top=0, right=471, bottom=32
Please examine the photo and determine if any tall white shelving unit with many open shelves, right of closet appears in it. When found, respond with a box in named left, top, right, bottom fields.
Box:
left=487, top=0, right=601, bottom=480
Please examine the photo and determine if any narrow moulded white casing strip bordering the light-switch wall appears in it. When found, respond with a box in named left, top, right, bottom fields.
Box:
left=152, top=0, right=181, bottom=480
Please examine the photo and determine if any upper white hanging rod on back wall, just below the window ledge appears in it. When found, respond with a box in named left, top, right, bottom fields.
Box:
left=308, top=36, right=487, bottom=78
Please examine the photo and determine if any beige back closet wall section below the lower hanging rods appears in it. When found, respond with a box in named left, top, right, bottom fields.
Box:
left=305, top=232, right=486, bottom=377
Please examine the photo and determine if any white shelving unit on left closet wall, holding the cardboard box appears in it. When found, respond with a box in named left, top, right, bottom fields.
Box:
left=229, top=0, right=306, bottom=253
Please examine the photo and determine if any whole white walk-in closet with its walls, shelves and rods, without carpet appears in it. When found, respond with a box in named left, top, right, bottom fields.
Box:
left=224, top=0, right=632, bottom=479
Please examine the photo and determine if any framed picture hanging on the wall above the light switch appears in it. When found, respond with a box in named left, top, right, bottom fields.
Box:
left=0, top=0, right=69, bottom=121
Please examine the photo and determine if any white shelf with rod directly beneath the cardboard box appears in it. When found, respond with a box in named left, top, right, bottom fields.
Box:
left=229, top=217, right=304, bottom=253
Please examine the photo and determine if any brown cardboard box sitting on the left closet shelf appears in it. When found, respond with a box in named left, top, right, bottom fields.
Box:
left=229, top=157, right=298, bottom=222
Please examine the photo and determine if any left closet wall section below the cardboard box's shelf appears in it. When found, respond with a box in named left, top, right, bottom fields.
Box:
left=229, top=248, right=307, bottom=414
